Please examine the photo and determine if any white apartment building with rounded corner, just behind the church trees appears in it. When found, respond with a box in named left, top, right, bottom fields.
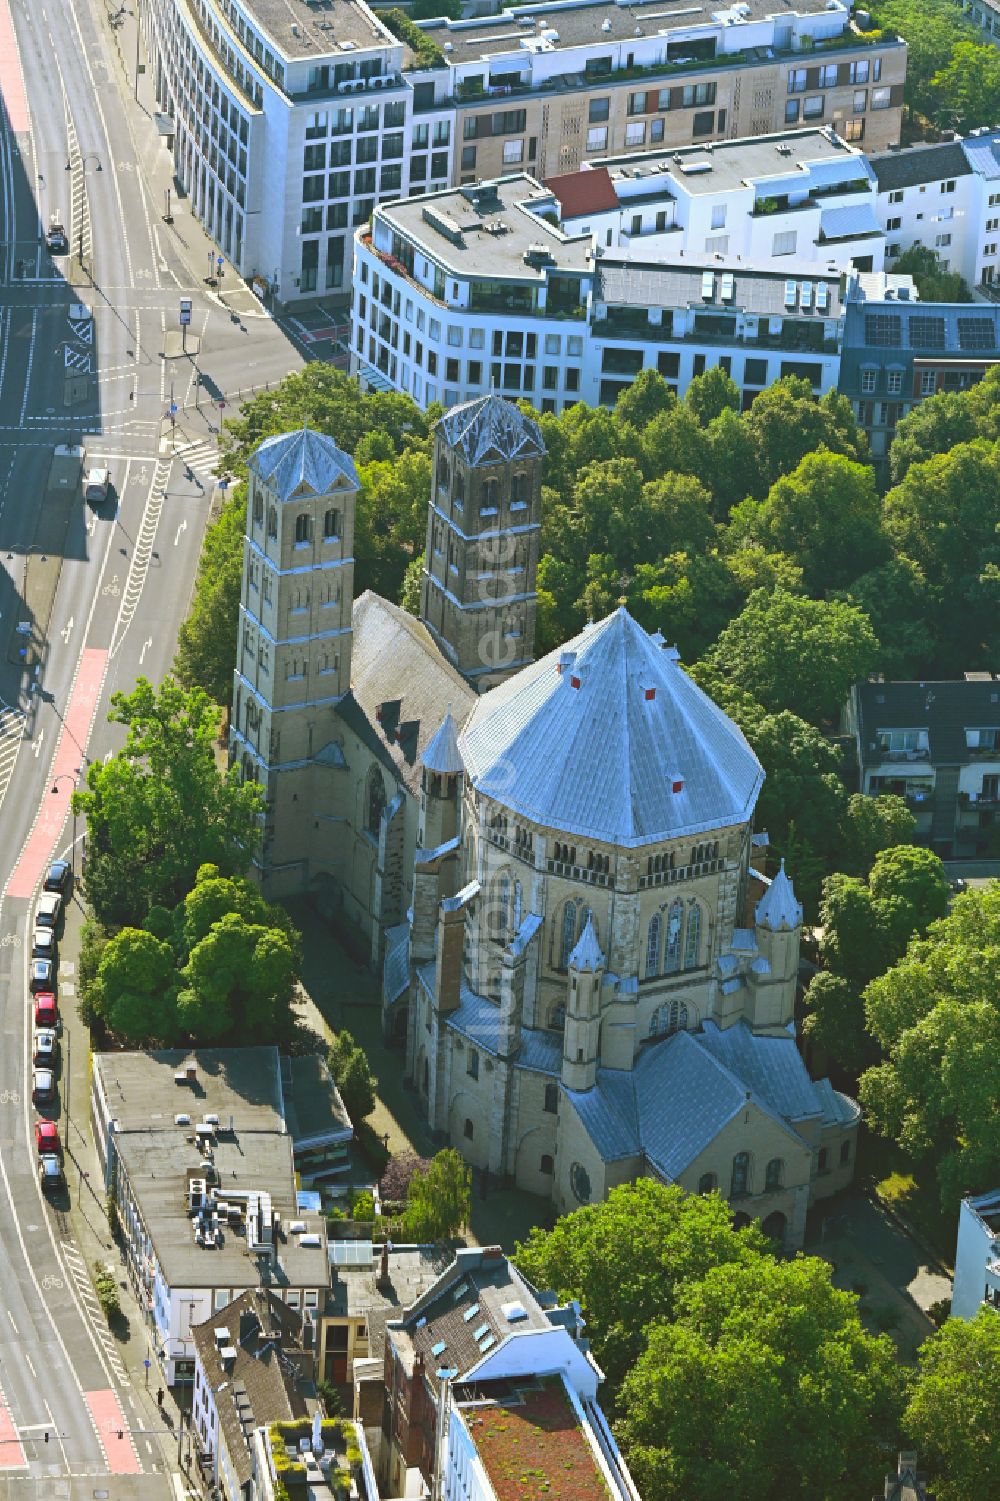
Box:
left=351, top=176, right=842, bottom=411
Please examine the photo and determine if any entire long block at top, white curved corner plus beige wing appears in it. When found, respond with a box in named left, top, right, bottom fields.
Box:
left=146, top=0, right=905, bottom=305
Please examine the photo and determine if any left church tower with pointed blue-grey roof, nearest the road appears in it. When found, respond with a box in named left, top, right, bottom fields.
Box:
left=230, top=428, right=359, bottom=896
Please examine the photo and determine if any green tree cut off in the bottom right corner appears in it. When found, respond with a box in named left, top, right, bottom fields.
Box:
left=904, top=1307, right=1000, bottom=1501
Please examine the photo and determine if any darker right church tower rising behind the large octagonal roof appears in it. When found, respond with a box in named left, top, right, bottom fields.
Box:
left=420, top=393, right=545, bottom=690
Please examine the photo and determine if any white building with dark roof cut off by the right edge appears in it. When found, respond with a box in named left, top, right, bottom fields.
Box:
left=871, top=129, right=1000, bottom=287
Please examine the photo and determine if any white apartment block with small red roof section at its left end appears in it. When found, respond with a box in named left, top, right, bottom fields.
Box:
left=545, top=126, right=884, bottom=272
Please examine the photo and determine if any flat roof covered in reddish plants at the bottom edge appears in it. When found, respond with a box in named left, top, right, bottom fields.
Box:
left=456, top=1376, right=608, bottom=1501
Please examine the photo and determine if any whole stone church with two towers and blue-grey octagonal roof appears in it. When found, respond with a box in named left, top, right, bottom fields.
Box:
left=230, top=395, right=859, bottom=1247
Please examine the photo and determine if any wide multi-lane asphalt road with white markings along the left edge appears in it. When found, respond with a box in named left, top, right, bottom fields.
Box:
left=0, top=0, right=300, bottom=1501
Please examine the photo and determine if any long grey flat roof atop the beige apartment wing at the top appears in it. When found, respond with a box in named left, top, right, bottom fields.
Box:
left=417, top=0, right=847, bottom=66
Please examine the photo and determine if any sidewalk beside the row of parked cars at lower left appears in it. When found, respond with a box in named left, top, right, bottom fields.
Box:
left=59, top=893, right=198, bottom=1489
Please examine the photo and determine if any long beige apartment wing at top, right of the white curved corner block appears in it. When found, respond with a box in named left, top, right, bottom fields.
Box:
left=411, top=0, right=907, bottom=183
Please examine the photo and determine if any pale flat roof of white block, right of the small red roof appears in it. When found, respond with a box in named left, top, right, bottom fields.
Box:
left=595, top=128, right=871, bottom=194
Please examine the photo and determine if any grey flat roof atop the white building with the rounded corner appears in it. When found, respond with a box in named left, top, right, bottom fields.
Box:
left=375, top=173, right=593, bottom=282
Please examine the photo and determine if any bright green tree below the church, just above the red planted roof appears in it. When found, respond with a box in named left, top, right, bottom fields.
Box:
left=515, top=1178, right=767, bottom=1388
